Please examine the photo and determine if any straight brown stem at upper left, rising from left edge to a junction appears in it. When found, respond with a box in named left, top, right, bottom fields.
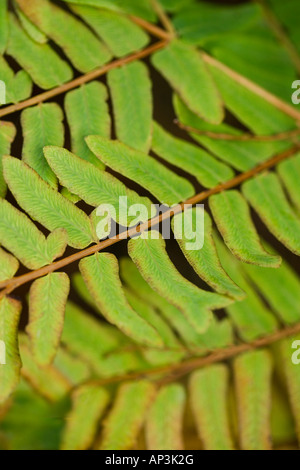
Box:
left=0, top=40, right=167, bottom=118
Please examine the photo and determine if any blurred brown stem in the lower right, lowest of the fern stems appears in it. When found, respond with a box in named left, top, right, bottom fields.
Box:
left=82, top=323, right=300, bottom=385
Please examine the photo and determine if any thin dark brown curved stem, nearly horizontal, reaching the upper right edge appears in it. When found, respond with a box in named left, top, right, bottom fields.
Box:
left=174, top=119, right=300, bottom=142
